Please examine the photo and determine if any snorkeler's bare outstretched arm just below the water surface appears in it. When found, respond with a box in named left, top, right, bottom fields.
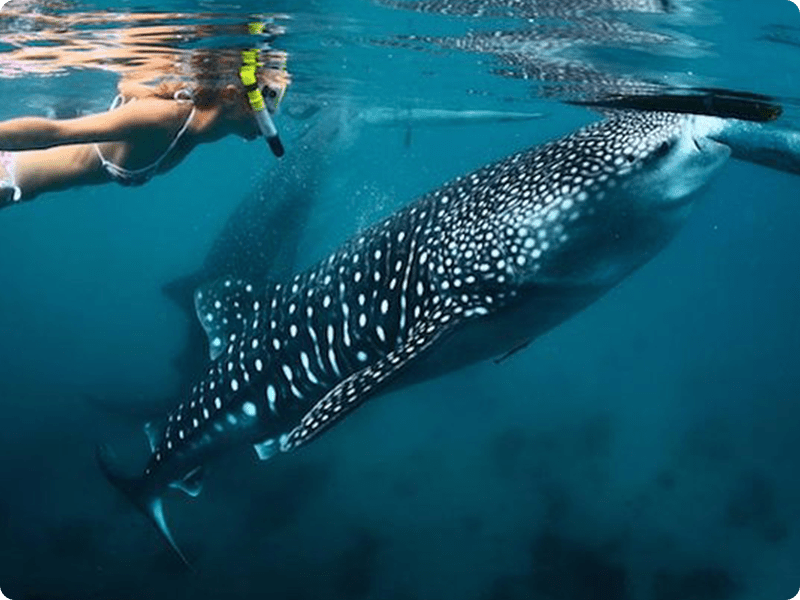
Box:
left=0, top=99, right=176, bottom=151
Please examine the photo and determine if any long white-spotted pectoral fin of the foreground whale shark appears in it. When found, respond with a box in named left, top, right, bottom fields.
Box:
left=280, top=312, right=468, bottom=452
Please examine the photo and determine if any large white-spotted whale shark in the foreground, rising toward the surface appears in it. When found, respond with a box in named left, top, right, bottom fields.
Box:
left=97, top=111, right=800, bottom=564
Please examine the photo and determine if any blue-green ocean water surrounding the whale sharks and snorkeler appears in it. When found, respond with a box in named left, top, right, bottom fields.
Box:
left=0, top=0, right=800, bottom=600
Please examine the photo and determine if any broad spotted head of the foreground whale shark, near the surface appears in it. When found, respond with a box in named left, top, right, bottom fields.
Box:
left=510, top=112, right=730, bottom=287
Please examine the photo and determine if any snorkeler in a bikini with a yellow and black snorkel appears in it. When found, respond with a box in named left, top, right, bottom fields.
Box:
left=0, top=49, right=289, bottom=208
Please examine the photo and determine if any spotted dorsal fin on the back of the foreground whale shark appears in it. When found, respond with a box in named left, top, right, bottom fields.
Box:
left=194, top=279, right=261, bottom=360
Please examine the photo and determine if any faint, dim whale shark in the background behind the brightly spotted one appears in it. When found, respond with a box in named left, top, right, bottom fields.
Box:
left=152, top=102, right=545, bottom=408
